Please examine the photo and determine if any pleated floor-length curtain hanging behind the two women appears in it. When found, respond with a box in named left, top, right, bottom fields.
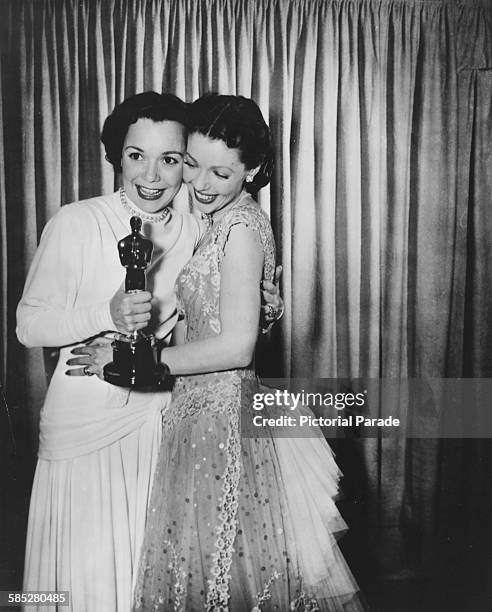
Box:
left=0, top=0, right=492, bottom=592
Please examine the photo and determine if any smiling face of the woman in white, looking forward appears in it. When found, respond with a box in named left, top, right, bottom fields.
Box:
left=121, top=118, right=186, bottom=213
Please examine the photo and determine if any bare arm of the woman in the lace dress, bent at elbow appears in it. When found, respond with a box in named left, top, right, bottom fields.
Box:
left=161, top=225, right=263, bottom=374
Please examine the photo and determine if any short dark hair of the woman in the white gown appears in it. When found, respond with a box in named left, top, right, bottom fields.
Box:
left=101, top=91, right=188, bottom=172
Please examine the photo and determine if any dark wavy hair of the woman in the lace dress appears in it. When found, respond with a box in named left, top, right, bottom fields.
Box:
left=187, top=93, right=273, bottom=193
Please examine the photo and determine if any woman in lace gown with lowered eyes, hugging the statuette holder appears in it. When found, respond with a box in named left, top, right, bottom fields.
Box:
left=135, top=94, right=359, bottom=612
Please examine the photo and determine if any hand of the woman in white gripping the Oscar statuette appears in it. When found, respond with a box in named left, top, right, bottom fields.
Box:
left=109, top=287, right=152, bottom=334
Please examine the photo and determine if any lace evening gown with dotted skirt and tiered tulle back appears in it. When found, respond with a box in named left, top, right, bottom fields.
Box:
left=135, top=196, right=359, bottom=612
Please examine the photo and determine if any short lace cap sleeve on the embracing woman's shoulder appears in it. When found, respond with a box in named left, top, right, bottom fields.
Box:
left=215, top=201, right=275, bottom=281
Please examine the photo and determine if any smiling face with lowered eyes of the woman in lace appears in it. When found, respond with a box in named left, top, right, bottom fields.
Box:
left=183, top=133, right=256, bottom=213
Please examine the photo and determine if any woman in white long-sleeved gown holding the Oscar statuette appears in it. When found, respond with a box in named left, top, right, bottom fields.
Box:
left=17, top=92, right=282, bottom=612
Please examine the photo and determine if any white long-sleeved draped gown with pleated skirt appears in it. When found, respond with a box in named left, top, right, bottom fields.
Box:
left=17, top=192, right=201, bottom=612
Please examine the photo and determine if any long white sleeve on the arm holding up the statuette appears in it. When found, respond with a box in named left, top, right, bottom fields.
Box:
left=17, top=204, right=114, bottom=347
